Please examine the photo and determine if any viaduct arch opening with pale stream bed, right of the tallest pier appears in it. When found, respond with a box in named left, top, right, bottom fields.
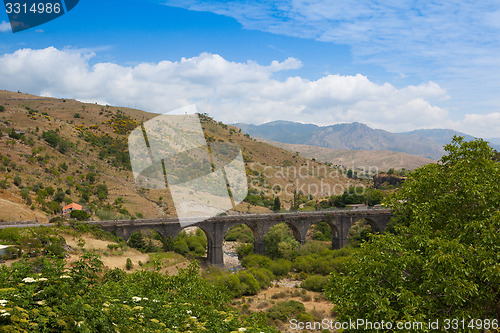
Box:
left=222, top=223, right=255, bottom=269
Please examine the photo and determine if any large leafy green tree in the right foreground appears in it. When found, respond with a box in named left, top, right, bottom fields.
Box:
left=327, top=137, right=500, bottom=322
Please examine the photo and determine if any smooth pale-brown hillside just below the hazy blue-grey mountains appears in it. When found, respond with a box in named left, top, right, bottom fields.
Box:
left=260, top=139, right=435, bottom=172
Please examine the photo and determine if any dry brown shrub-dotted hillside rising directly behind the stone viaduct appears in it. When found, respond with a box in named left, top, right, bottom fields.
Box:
left=0, top=91, right=360, bottom=220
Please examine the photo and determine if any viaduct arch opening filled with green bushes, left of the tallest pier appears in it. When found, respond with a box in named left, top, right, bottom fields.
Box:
left=172, top=227, right=210, bottom=262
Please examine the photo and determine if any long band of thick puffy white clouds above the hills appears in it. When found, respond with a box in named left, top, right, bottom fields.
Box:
left=0, top=47, right=498, bottom=135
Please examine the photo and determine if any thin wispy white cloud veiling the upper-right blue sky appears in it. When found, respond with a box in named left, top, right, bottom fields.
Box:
left=161, top=0, right=500, bottom=126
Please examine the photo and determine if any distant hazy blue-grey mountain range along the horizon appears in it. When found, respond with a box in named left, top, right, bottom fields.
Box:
left=233, top=120, right=500, bottom=160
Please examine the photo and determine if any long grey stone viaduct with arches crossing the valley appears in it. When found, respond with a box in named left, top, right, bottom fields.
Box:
left=88, top=209, right=391, bottom=266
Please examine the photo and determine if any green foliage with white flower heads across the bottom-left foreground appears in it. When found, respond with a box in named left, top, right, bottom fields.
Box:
left=0, top=254, right=276, bottom=332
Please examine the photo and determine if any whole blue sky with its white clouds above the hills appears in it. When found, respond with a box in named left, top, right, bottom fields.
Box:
left=0, top=0, right=500, bottom=137
